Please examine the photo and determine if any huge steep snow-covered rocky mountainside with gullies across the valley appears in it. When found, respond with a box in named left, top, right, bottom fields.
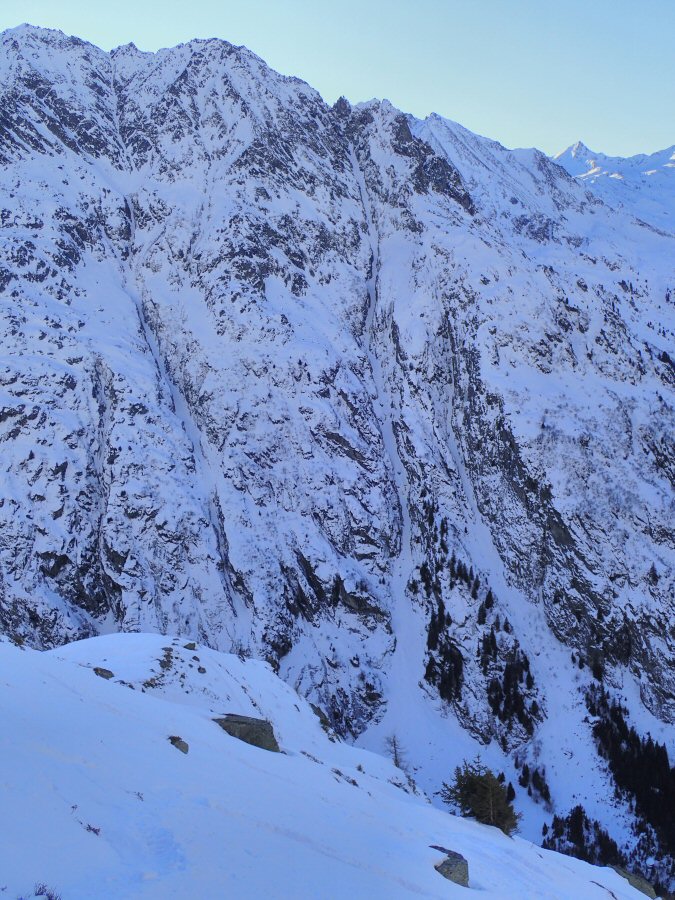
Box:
left=0, top=26, right=675, bottom=892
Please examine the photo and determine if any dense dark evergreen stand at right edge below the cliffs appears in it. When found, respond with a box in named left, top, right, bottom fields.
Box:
left=586, top=685, right=675, bottom=856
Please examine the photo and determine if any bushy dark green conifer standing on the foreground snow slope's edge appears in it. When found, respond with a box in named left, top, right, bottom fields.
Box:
left=439, top=759, right=520, bottom=834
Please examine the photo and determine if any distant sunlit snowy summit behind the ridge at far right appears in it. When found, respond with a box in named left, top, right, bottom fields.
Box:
left=553, top=141, right=675, bottom=231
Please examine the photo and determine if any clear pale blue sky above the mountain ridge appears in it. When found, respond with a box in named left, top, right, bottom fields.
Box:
left=0, top=0, right=675, bottom=156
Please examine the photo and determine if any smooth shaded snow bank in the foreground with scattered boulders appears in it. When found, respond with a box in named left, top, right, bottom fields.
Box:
left=0, top=635, right=656, bottom=900
